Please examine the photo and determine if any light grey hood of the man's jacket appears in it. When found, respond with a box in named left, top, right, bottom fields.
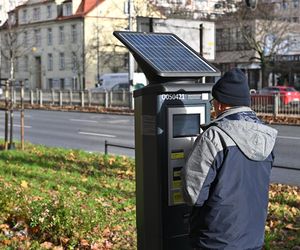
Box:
left=212, top=107, right=277, bottom=161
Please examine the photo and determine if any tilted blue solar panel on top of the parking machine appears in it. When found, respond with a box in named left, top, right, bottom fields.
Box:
left=116, top=32, right=218, bottom=76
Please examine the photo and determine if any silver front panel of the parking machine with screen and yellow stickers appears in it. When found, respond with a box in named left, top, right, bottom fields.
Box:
left=168, top=105, right=206, bottom=206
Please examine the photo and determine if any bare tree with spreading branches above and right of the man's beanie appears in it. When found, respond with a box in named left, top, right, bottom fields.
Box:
left=219, top=3, right=292, bottom=87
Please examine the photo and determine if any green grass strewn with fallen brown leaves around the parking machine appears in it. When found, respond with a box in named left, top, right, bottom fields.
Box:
left=0, top=144, right=300, bottom=250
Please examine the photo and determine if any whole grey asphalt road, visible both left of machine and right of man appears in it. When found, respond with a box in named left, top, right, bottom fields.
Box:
left=0, top=110, right=300, bottom=185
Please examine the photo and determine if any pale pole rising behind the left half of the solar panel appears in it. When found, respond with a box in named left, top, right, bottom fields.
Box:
left=128, top=0, right=134, bottom=109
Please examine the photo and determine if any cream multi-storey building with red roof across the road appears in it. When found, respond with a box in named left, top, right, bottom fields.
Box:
left=0, top=0, right=155, bottom=90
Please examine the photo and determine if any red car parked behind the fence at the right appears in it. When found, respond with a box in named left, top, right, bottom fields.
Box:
left=252, top=86, right=300, bottom=105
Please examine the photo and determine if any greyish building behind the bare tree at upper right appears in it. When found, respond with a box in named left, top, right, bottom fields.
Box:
left=215, top=1, right=300, bottom=89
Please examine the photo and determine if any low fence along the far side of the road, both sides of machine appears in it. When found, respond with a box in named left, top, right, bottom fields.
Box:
left=0, top=89, right=300, bottom=117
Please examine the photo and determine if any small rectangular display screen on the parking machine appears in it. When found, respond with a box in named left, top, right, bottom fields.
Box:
left=173, top=114, right=200, bottom=138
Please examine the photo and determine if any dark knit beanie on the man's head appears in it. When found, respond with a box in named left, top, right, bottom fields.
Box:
left=212, top=68, right=251, bottom=106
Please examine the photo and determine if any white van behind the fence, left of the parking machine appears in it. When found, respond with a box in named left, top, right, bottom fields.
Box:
left=96, top=73, right=147, bottom=91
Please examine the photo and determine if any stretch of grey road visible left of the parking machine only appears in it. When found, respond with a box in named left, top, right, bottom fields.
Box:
left=0, top=110, right=134, bottom=157
